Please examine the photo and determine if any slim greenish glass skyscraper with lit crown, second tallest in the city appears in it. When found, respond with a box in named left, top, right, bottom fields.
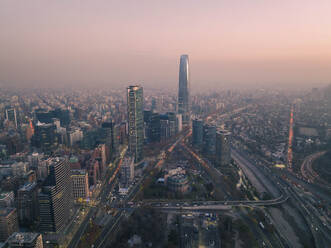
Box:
left=127, top=85, right=144, bottom=163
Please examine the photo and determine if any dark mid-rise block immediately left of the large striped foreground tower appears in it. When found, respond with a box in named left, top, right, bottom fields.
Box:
left=17, top=182, right=39, bottom=226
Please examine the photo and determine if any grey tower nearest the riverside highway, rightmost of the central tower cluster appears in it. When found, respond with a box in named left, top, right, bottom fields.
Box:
left=216, top=130, right=231, bottom=166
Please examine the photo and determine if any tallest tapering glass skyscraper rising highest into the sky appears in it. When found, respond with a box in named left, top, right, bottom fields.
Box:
left=177, top=55, right=190, bottom=124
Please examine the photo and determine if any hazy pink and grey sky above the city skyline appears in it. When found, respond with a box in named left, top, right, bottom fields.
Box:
left=0, top=0, right=331, bottom=89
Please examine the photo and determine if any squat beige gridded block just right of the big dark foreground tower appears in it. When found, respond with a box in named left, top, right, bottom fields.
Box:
left=71, top=170, right=89, bottom=200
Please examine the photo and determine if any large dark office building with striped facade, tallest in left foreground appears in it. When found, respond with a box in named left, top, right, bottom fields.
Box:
left=38, top=157, right=73, bottom=232
